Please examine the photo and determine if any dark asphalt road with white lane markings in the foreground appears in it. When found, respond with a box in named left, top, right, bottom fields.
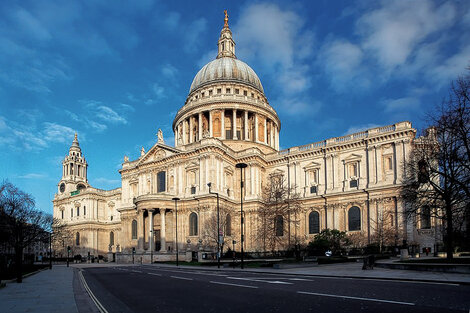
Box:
left=83, top=265, right=470, bottom=313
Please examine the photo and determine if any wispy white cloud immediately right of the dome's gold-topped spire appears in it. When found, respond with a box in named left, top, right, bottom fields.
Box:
left=234, top=3, right=320, bottom=115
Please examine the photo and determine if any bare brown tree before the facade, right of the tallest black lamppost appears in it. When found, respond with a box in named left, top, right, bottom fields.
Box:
left=257, top=174, right=301, bottom=252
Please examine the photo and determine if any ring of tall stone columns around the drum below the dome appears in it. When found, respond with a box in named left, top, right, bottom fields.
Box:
left=175, top=109, right=279, bottom=149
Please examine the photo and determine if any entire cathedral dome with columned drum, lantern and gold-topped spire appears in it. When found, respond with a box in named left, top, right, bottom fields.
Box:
left=173, top=10, right=281, bottom=152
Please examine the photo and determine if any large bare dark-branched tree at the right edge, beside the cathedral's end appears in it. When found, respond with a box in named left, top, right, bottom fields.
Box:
left=402, top=70, right=470, bottom=259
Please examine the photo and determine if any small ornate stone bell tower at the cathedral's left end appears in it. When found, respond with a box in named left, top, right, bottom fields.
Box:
left=59, top=133, right=88, bottom=194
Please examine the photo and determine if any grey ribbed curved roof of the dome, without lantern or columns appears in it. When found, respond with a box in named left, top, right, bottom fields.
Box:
left=189, top=57, right=264, bottom=93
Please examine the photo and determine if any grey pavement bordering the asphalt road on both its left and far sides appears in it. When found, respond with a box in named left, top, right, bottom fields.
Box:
left=0, top=263, right=470, bottom=313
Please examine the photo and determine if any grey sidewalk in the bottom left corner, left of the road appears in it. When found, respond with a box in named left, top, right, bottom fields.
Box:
left=0, top=265, right=78, bottom=313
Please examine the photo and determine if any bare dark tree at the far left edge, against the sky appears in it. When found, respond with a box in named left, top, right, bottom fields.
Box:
left=0, top=181, right=52, bottom=283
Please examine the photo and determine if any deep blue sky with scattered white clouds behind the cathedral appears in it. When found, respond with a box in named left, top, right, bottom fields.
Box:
left=0, top=0, right=470, bottom=213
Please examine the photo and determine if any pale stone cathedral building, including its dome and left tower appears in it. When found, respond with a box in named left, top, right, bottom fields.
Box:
left=53, top=14, right=436, bottom=260
